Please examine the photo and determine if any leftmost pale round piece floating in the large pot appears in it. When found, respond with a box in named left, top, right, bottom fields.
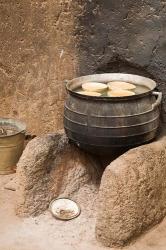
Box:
left=82, top=82, right=108, bottom=92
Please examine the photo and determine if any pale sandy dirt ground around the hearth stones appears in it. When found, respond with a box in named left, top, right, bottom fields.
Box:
left=0, top=175, right=166, bottom=250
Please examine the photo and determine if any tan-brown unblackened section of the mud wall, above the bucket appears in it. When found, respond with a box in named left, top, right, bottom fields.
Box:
left=0, top=0, right=82, bottom=133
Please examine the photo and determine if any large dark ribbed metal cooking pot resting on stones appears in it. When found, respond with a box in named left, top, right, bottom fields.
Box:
left=64, top=73, right=162, bottom=153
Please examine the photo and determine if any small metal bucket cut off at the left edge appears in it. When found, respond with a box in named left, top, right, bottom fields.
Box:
left=0, top=118, right=26, bottom=175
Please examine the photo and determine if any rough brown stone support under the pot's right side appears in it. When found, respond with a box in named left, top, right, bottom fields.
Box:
left=96, top=136, right=166, bottom=247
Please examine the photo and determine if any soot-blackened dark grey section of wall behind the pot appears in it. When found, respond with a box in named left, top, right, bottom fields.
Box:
left=76, top=0, right=166, bottom=81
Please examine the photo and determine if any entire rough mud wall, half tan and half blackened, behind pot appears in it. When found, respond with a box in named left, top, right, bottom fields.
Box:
left=0, top=0, right=166, bottom=134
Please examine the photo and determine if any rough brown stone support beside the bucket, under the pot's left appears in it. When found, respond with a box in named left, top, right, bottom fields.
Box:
left=16, top=132, right=101, bottom=216
